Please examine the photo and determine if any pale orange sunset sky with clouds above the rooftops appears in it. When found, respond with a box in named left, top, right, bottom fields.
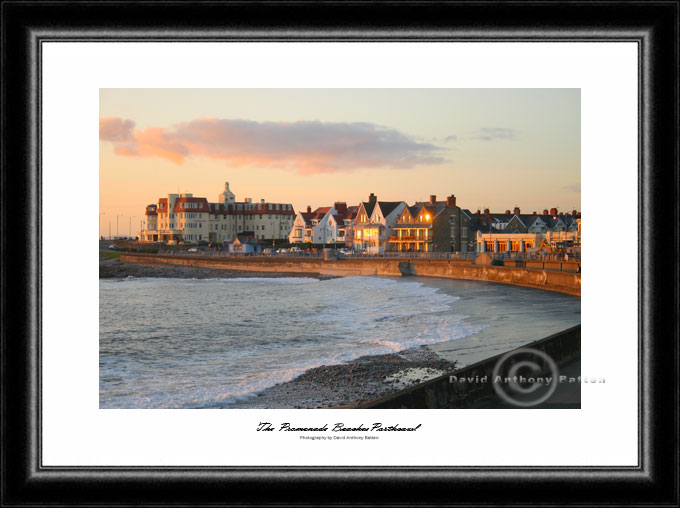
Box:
left=99, top=89, right=581, bottom=235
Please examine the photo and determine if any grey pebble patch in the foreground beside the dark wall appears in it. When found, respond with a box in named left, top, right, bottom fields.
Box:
left=224, top=346, right=456, bottom=409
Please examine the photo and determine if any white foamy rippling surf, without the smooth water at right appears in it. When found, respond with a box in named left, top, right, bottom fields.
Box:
left=100, top=277, right=485, bottom=408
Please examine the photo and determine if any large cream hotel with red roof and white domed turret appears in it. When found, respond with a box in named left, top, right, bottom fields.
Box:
left=140, top=182, right=295, bottom=244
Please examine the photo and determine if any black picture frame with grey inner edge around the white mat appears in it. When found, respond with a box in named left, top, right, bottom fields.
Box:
left=1, top=1, right=679, bottom=506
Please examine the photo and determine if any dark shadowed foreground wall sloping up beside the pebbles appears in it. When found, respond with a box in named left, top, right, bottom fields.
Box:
left=357, top=325, right=581, bottom=409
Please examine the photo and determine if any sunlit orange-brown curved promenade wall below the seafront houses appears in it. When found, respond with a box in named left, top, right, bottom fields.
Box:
left=120, top=253, right=581, bottom=296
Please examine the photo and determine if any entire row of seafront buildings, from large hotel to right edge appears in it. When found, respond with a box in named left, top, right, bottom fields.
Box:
left=140, top=182, right=581, bottom=255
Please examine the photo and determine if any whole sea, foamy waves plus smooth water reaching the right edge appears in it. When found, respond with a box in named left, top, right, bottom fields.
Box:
left=99, top=277, right=581, bottom=409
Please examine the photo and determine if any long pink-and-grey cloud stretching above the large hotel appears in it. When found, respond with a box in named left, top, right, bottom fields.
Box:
left=99, top=118, right=445, bottom=174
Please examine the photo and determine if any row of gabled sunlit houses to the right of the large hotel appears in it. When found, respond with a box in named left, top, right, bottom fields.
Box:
left=288, top=193, right=581, bottom=254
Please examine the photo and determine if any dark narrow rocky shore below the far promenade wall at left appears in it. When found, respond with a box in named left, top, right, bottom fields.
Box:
left=99, top=257, right=334, bottom=280
